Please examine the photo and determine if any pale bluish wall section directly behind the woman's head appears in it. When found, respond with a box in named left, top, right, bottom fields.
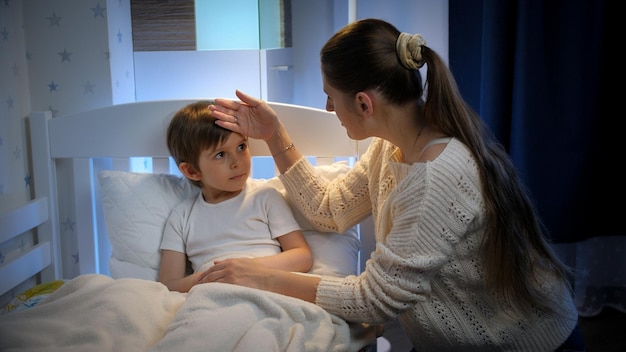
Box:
left=291, top=0, right=448, bottom=109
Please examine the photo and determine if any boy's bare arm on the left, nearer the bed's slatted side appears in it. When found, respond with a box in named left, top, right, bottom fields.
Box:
left=158, top=249, right=199, bottom=292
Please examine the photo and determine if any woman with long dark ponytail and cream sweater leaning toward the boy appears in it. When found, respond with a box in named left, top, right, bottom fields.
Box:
left=201, top=19, right=578, bottom=351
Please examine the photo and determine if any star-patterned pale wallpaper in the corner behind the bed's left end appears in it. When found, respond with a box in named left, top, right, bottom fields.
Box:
left=0, top=0, right=134, bottom=304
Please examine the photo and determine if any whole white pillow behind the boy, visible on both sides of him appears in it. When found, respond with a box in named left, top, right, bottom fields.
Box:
left=98, top=162, right=360, bottom=280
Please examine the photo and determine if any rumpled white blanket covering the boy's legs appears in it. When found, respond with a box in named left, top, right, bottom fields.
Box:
left=0, top=275, right=376, bottom=352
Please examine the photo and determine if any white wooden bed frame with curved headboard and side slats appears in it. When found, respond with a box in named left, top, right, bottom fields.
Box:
left=0, top=99, right=374, bottom=302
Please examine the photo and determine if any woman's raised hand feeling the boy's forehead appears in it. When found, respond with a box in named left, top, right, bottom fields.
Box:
left=209, top=90, right=280, bottom=141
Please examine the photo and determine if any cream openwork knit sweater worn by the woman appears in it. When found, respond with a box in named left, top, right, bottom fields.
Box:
left=281, top=139, right=578, bottom=352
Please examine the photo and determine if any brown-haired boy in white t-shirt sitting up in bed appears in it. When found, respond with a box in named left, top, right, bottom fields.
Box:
left=158, top=101, right=313, bottom=292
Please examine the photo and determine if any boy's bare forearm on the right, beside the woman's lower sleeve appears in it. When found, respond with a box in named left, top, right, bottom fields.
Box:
left=254, top=230, right=313, bottom=273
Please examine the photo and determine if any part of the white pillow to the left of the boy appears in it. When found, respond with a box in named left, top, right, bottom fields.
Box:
left=98, top=171, right=199, bottom=280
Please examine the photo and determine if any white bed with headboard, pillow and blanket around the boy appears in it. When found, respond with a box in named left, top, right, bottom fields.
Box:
left=0, top=99, right=382, bottom=351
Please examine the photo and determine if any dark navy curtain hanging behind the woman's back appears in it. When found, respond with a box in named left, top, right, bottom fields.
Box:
left=449, top=0, right=626, bottom=243
